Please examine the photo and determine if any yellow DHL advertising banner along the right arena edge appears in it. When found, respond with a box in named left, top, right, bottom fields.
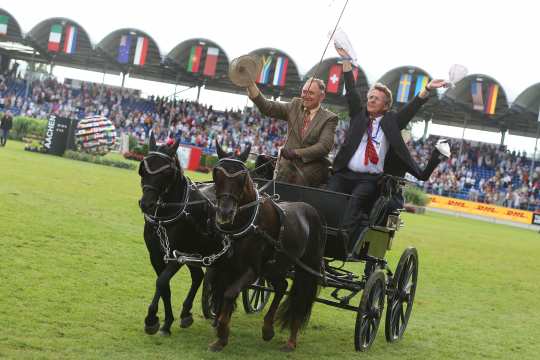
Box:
left=428, top=194, right=533, bottom=224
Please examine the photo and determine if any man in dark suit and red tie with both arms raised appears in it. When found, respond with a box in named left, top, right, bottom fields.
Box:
left=328, top=49, right=450, bottom=245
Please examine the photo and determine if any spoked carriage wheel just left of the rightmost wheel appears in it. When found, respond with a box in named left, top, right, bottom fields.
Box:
left=354, top=270, right=386, bottom=351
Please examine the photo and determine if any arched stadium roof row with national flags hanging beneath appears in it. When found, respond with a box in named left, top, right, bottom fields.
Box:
left=0, top=9, right=540, bottom=137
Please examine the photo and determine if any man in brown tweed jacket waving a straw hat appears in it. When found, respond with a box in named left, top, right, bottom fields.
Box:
left=247, top=78, right=338, bottom=186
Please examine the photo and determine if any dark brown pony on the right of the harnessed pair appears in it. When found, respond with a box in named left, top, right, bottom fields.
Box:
left=210, top=145, right=325, bottom=351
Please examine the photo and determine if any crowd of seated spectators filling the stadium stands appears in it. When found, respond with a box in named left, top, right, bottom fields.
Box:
left=0, top=72, right=540, bottom=210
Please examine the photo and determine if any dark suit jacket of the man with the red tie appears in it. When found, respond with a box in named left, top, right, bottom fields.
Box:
left=333, top=71, right=432, bottom=179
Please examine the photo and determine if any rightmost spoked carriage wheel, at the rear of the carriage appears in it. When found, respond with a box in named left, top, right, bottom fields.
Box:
left=384, top=247, right=418, bottom=342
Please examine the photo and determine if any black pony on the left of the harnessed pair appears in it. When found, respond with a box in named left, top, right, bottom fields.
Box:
left=139, top=134, right=221, bottom=335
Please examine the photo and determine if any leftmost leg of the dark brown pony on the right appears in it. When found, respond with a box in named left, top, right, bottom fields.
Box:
left=209, top=268, right=257, bottom=351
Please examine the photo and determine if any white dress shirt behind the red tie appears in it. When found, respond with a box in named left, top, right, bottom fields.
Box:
left=348, top=115, right=390, bottom=174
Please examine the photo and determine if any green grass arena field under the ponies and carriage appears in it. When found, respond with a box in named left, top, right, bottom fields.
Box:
left=0, top=141, right=540, bottom=360
